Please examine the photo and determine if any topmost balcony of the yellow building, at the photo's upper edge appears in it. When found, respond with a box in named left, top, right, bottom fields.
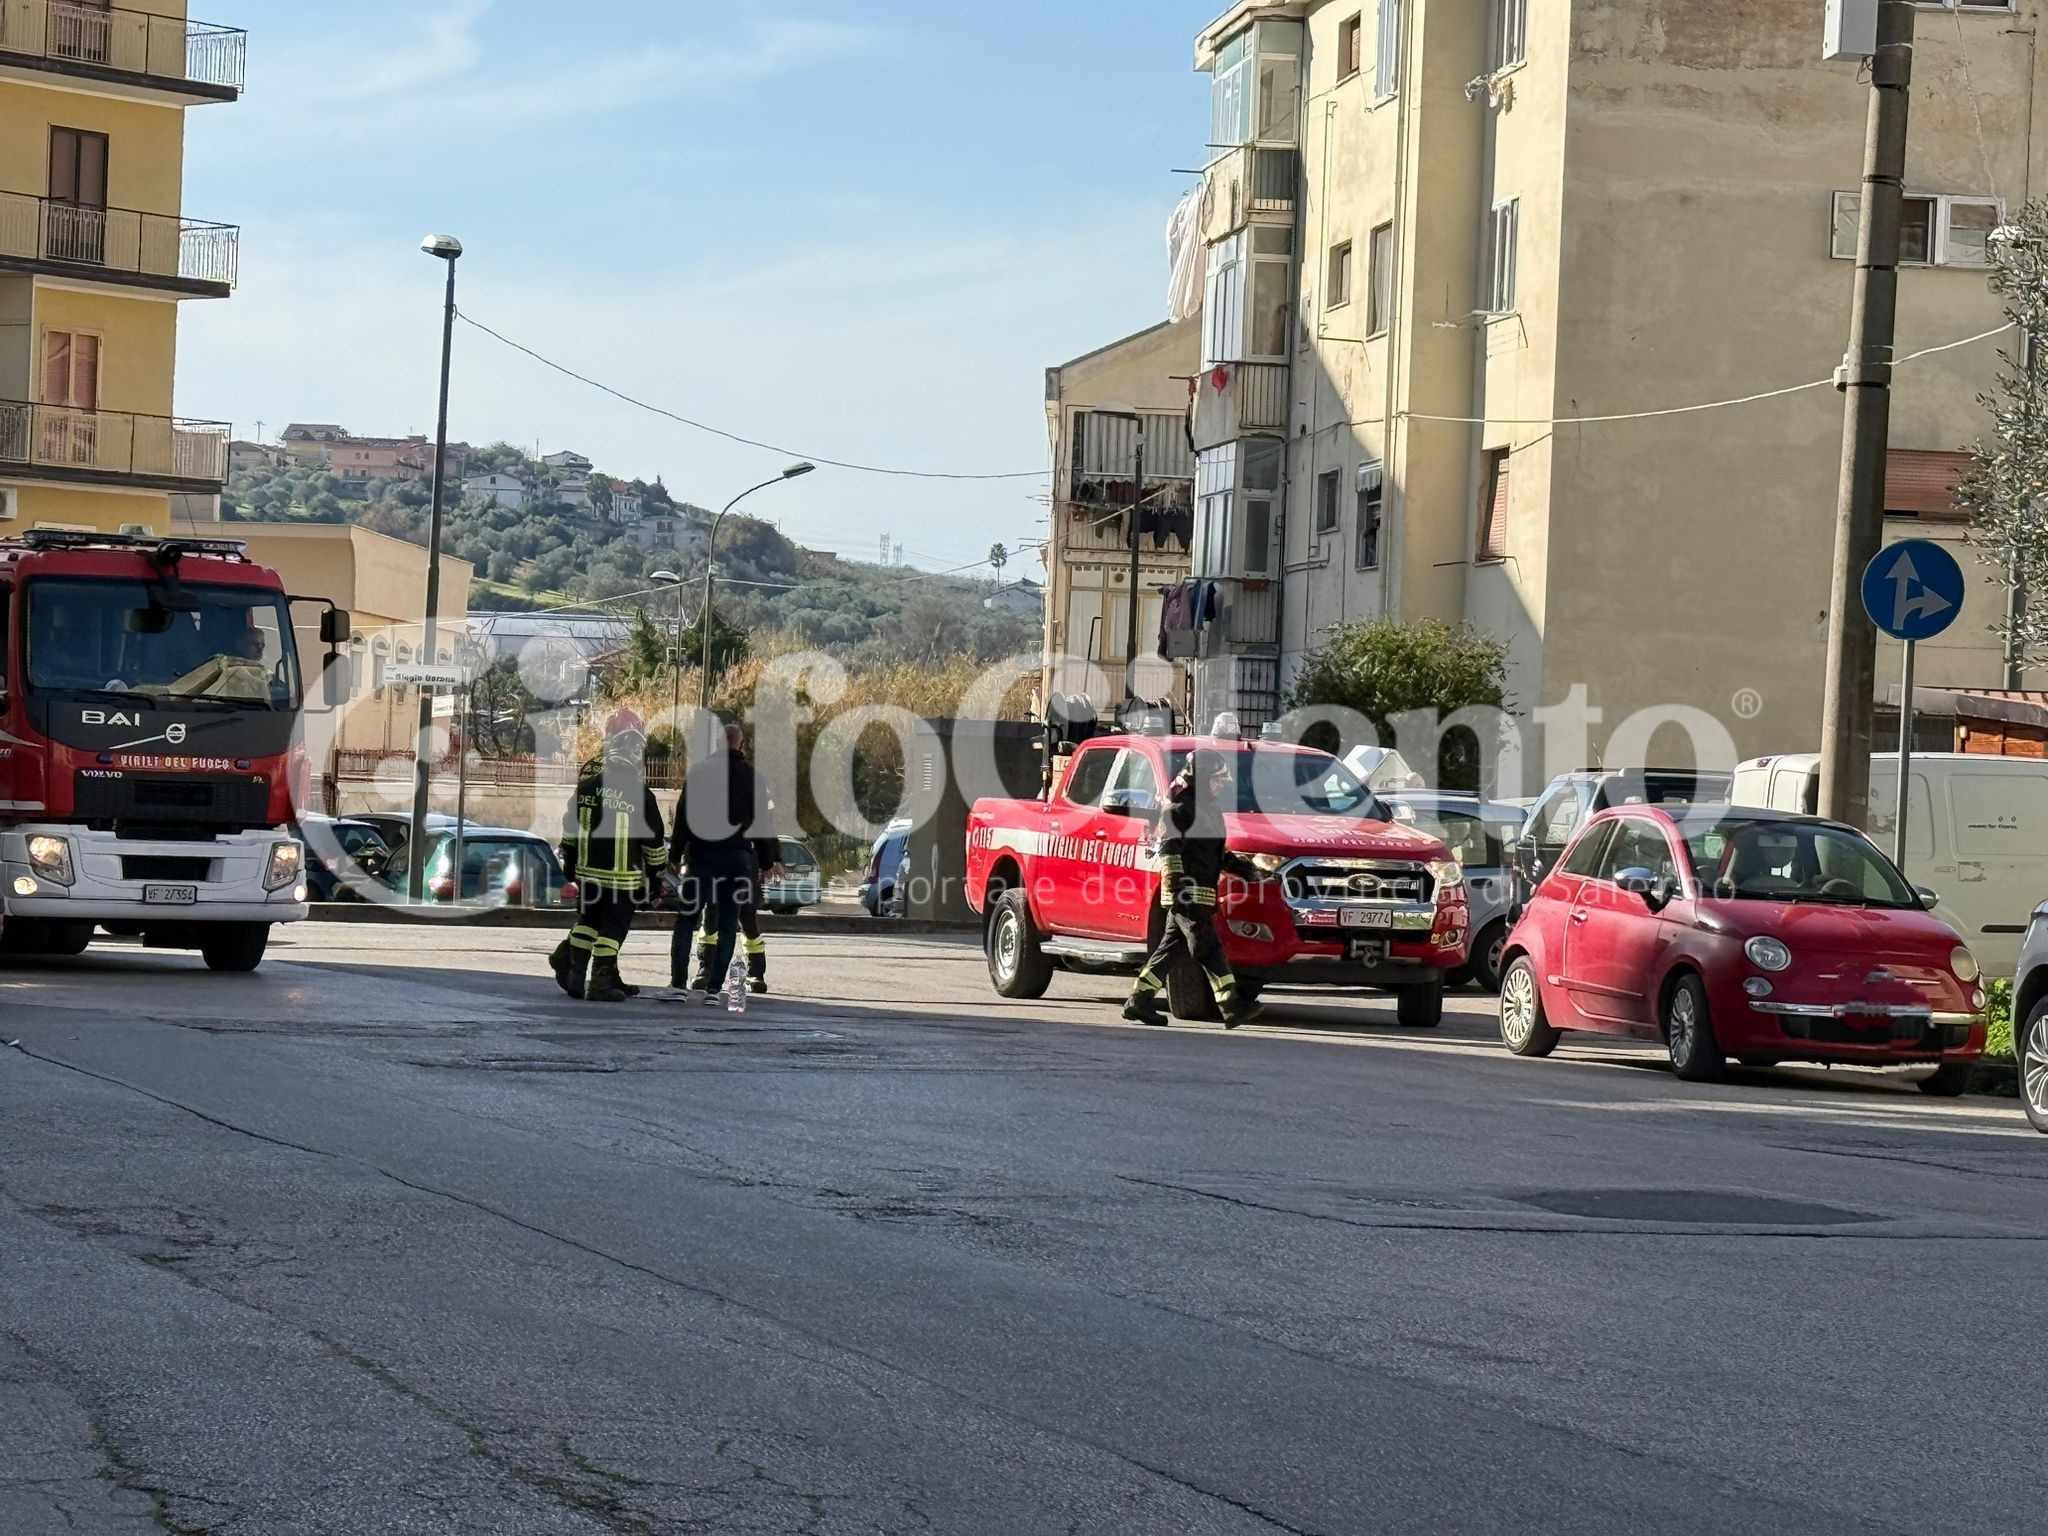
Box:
left=0, top=0, right=248, bottom=106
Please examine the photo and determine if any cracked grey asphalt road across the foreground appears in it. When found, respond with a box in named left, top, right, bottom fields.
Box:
left=0, top=926, right=2048, bottom=1536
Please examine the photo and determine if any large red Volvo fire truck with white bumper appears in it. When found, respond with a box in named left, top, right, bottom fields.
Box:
left=0, top=530, right=348, bottom=971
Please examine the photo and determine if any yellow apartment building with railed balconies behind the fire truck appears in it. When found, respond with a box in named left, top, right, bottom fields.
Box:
left=0, top=0, right=246, bottom=532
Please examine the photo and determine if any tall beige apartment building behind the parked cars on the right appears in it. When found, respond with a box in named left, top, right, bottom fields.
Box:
left=1194, top=0, right=2048, bottom=770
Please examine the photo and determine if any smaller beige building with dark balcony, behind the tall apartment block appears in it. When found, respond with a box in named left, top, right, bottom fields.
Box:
left=1040, top=319, right=1200, bottom=717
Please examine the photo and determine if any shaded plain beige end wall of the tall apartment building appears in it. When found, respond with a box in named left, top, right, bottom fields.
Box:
left=1548, top=0, right=2042, bottom=754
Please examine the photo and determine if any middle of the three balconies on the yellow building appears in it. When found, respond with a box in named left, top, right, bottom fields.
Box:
left=0, top=193, right=242, bottom=299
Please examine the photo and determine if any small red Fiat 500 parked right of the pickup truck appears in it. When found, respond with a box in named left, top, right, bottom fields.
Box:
left=1501, top=805, right=1985, bottom=1096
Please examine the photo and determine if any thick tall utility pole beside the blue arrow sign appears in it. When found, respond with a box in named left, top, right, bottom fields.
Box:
left=1821, top=0, right=1913, bottom=827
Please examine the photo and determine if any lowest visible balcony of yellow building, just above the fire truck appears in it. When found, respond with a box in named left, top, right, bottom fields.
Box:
left=0, top=399, right=229, bottom=496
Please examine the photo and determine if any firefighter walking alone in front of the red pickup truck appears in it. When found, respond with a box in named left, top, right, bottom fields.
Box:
left=1124, top=748, right=1260, bottom=1030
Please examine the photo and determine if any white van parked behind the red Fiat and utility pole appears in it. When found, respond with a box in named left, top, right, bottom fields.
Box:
left=1731, top=752, right=2048, bottom=977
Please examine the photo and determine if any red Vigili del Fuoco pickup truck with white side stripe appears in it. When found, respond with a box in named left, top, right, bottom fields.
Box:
left=967, top=735, right=1468, bottom=1028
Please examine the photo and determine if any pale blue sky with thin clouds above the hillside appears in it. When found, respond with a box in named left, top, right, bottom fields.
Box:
left=178, top=0, right=1210, bottom=575
